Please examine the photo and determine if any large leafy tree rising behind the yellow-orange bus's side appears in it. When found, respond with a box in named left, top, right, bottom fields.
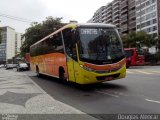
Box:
left=21, top=16, right=64, bottom=56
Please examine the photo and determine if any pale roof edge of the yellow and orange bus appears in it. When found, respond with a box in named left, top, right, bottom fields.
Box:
left=30, top=23, right=116, bottom=47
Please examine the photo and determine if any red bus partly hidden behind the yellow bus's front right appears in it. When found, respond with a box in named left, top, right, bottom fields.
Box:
left=124, top=48, right=145, bottom=68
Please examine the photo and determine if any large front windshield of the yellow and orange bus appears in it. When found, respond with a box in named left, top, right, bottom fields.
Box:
left=78, top=28, right=125, bottom=64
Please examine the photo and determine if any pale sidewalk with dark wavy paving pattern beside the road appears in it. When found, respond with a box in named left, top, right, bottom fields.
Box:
left=0, top=69, right=97, bottom=120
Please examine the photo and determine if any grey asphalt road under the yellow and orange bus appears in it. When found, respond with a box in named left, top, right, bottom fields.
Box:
left=26, top=66, right=160, bottom=118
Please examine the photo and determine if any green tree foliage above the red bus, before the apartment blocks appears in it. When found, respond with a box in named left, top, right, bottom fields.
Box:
left=122, top=31, right=156, bottom=48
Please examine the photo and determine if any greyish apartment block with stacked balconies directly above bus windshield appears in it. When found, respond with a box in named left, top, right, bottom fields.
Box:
left=89, top=0, right=136, bottom=34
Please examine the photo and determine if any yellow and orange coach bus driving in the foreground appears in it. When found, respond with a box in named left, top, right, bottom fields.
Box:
left=30, top=23, right=126, bottom=84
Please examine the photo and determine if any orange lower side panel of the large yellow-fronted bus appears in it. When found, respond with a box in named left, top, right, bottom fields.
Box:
left=31, top=53, right=67, bottom=77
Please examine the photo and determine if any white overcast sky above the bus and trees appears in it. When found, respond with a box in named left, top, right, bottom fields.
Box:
left=0, top=0, right=112, bottom=33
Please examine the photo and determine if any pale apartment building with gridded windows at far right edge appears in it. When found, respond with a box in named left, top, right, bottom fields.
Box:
left=136, top=0, right=160, bottom=36
